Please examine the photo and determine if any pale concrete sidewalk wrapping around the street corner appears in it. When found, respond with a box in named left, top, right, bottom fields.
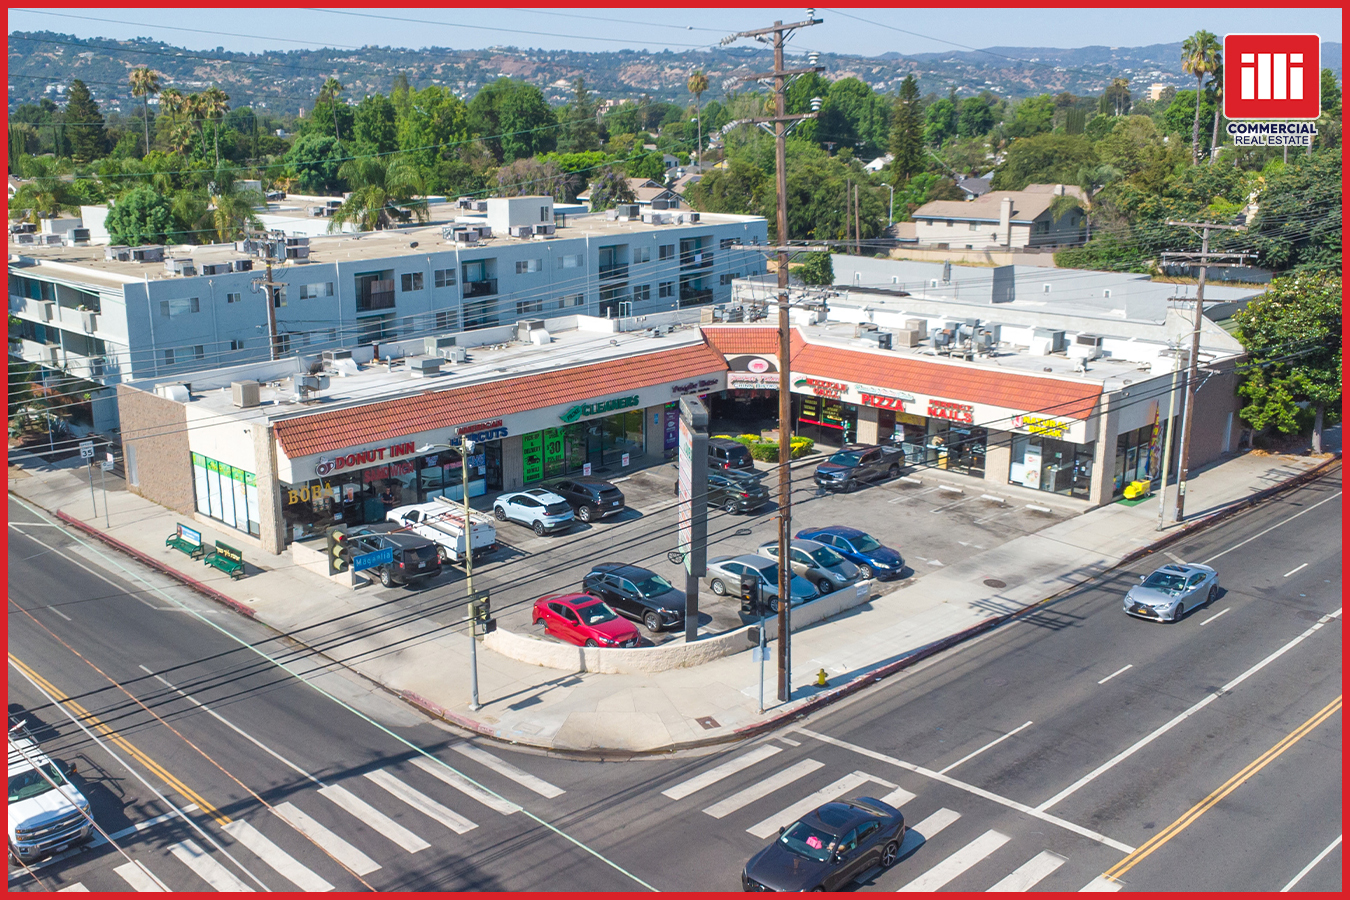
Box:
left=9, top=429, right=1341, bottom=753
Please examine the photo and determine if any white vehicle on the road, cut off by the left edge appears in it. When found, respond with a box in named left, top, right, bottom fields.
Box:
left=9, top=734, right=93, bottom=862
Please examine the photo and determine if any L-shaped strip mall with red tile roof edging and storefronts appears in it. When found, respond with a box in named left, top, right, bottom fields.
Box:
left=119, top=295, right=1238, bottom=553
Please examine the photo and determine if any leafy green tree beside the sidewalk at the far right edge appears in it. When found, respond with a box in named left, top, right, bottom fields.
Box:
left=1234, top=271, right=1341, bottom=453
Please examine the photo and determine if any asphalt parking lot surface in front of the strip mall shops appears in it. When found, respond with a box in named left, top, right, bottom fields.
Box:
left=362, top=456, right=1072, bottom=644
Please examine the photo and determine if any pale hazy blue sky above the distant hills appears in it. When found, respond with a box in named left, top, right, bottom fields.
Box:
left=9, top=5, right=1341, bottom=55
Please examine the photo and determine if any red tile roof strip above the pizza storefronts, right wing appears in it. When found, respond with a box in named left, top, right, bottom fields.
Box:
left=792, top=344, right=1102, bottom=418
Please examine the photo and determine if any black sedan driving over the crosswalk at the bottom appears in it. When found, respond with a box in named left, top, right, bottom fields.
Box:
left=741, top=797, right=906, bottom=891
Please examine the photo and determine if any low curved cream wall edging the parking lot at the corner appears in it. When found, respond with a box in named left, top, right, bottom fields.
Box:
left=483, top=582, right=872, bottom=675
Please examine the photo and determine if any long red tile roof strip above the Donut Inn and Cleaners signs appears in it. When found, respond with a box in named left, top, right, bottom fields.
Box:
left=275, top=344, right=726, bottom=459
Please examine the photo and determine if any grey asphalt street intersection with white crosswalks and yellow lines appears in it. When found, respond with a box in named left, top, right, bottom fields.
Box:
left=9, top=471, right=1342, bottom=891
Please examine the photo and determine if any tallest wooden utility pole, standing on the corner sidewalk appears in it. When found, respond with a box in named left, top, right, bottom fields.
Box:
left=722, top=9, right=824, bottom=703
